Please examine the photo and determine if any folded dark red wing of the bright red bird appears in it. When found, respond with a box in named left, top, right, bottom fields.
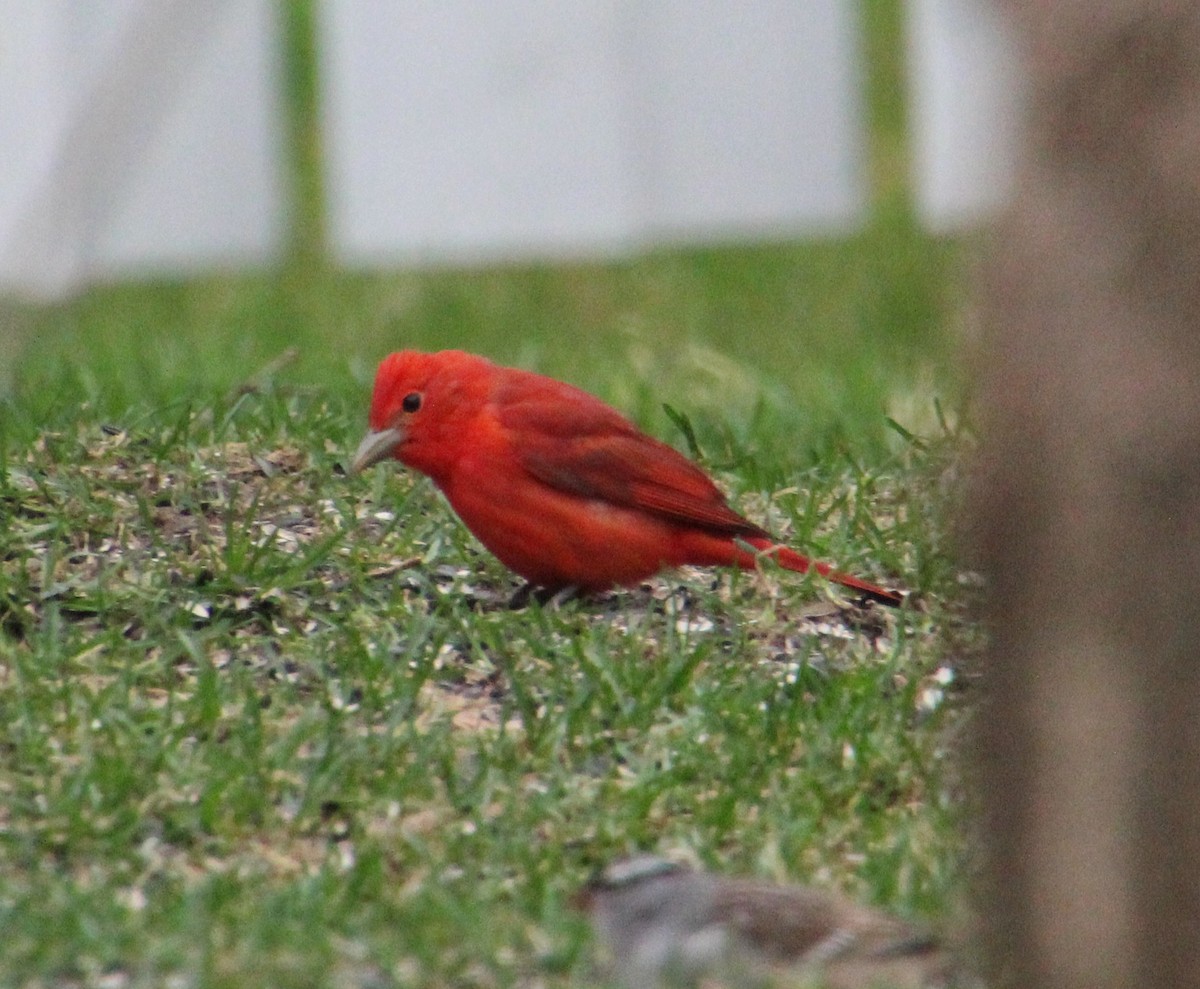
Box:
left=498, top=389, right=769, bottom=538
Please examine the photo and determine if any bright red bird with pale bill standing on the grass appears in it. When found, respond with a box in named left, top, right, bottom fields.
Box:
left=352, top=350, right=901, bottom=605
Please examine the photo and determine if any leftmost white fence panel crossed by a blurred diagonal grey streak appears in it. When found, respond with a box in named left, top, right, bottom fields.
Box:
left=0, top=0, right=283, bottom=295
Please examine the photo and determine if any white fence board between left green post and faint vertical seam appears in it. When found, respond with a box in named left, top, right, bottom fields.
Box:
left=322, top=0, right=629, bottom=264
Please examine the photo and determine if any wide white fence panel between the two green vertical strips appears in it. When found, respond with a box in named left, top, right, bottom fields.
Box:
left=322, top=0, right=865, bottom=264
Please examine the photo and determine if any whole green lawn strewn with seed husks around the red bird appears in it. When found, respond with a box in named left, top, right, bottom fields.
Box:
left=0, top=5, right=976, bottom=989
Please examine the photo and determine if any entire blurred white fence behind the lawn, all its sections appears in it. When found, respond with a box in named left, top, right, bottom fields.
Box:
left=0, top=0, right=1019, bottom=296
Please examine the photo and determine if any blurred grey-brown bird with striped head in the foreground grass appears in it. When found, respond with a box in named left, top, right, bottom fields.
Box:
left=574, top=856, right=949, bottom=989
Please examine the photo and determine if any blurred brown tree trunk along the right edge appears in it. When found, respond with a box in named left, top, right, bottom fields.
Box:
left=972, top=0, right=1200, bottom=989
